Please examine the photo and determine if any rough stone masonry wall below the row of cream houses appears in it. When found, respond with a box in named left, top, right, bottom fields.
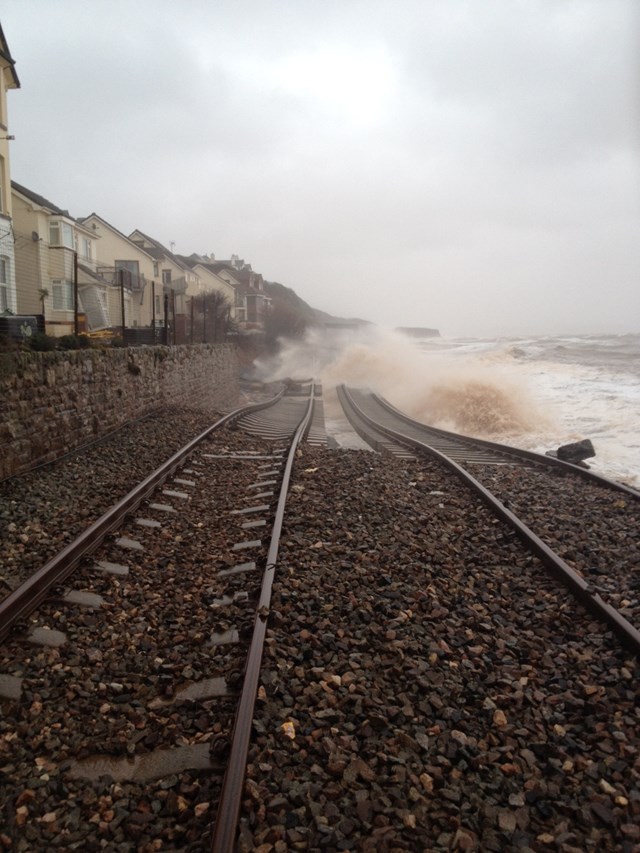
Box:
left=0, top=344, right=239, bottom=479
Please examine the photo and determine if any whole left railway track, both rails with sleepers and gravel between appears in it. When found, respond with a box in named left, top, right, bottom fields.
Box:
left=0, top=386, right=313, bottom=849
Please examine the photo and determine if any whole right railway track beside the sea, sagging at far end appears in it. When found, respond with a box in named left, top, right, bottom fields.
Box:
left=339, top=386, right=640, bottom=655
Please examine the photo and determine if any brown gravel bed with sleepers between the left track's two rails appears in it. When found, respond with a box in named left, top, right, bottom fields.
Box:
left=0, top=422, right=281, bottom=853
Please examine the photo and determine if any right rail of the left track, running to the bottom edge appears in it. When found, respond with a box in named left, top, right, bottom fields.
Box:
left=211, top=383, right=315, bottom=853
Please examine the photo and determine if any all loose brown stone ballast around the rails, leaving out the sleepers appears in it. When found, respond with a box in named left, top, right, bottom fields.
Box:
left=0, top=412, right=640, bottom=853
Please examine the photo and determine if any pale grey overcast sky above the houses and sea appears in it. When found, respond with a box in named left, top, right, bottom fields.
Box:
left=1, top=0, right=640, bottom=336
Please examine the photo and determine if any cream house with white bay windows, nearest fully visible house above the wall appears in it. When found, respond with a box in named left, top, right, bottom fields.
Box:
left=11, top=181, right=99, bottom=336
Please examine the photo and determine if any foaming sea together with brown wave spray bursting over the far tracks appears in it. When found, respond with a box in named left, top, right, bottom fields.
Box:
left=261, top=327, right=640, bottom=489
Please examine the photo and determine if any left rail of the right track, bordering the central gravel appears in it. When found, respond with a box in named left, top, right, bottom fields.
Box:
left=340, top=385, right=640, bottom=657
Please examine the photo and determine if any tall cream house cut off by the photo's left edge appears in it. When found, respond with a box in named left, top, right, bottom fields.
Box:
left=0, top=26, right=20, bottom=314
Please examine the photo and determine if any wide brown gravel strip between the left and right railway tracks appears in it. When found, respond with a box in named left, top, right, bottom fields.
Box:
left=240, top=450, right=640, bottom=853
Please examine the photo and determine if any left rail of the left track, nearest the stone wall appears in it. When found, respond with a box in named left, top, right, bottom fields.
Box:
left=0, top=389, right=284, bottom=640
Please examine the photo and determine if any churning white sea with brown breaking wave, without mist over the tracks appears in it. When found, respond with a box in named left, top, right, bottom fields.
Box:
left=391, top=334, right=640, bottom=488
